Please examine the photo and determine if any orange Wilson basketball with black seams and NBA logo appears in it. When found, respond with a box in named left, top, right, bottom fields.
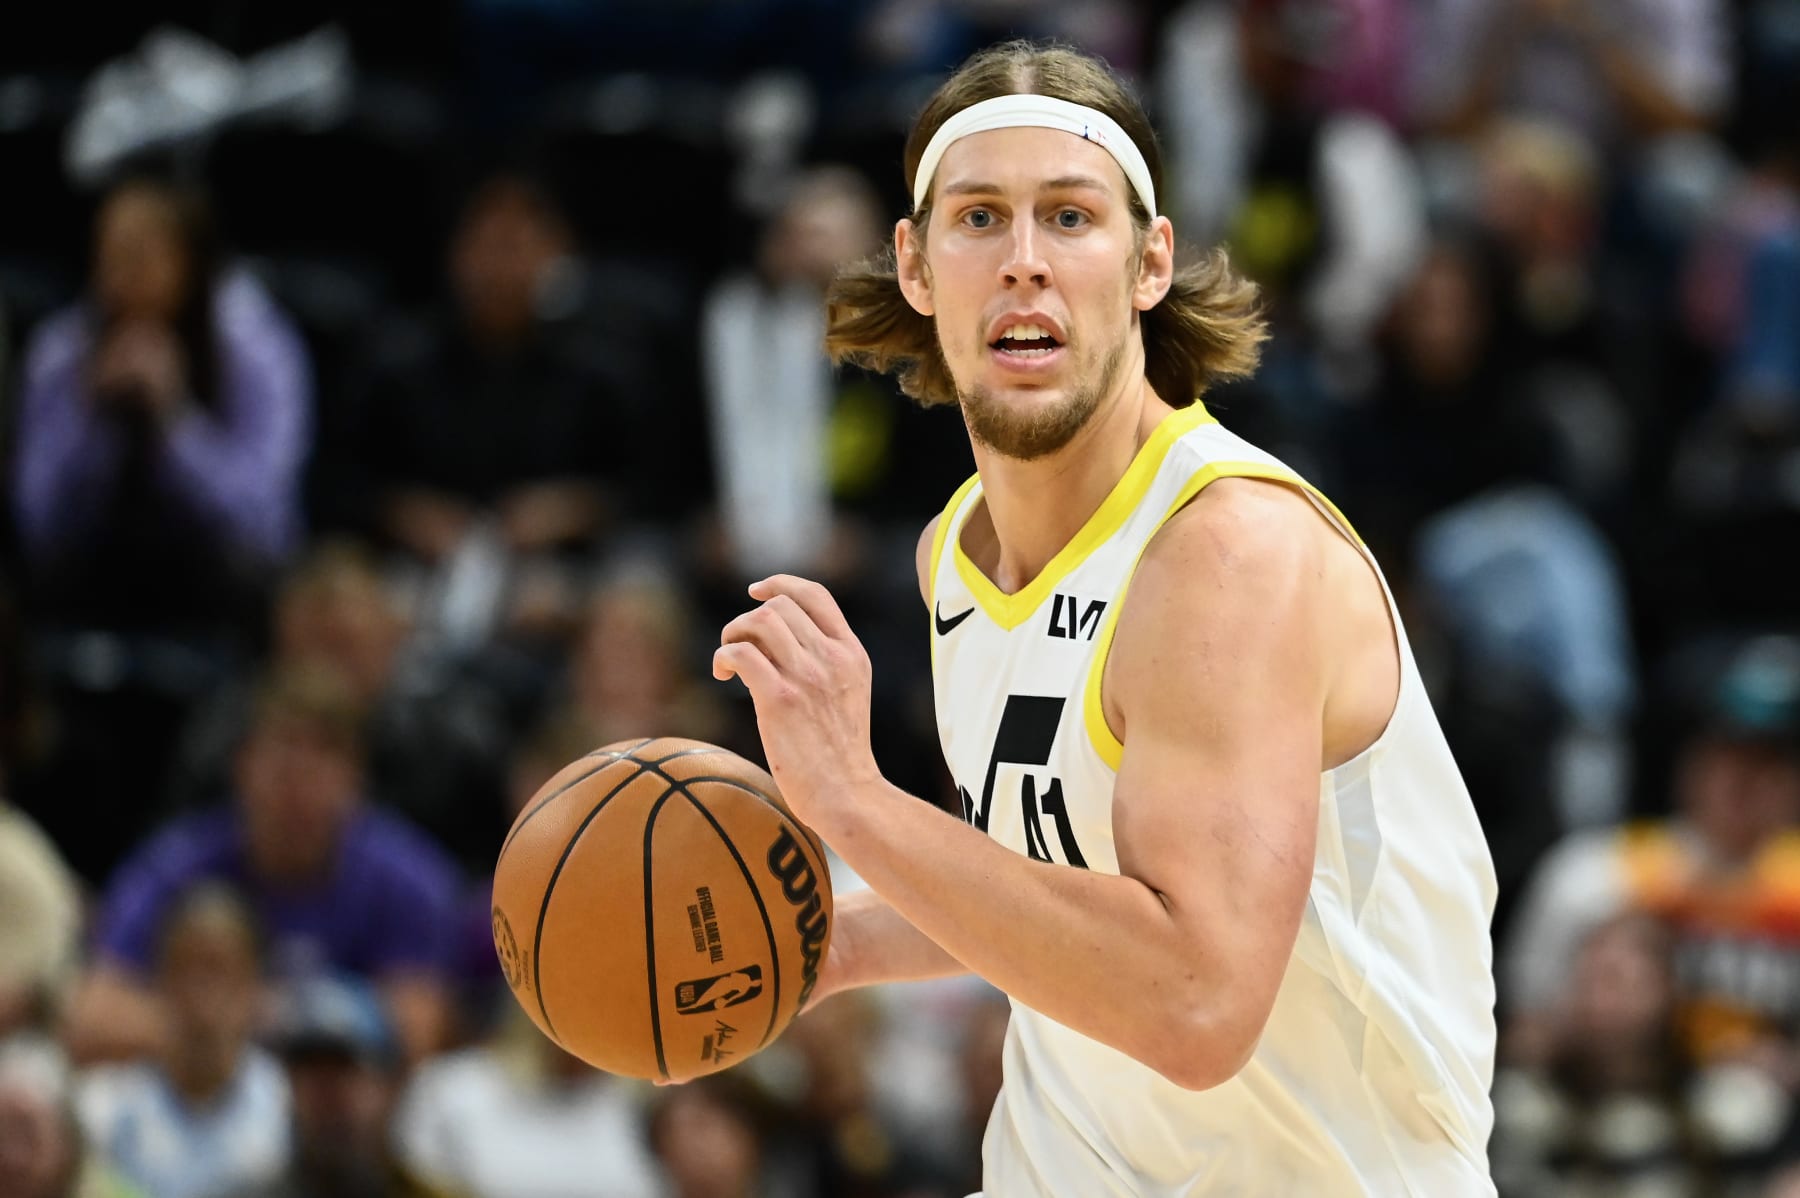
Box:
left=493, top=738, right=832, bottom=1081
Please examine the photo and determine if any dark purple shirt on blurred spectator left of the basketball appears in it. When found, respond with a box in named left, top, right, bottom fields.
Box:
left=99, top=808, right=461, bottom=979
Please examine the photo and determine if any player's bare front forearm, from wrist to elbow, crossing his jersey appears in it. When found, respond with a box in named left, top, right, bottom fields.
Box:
left=815, top=769, right=1260, bottom=1088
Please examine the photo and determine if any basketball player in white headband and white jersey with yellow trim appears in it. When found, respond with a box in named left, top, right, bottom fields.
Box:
left=713, top=43, right=1494, bottom=1198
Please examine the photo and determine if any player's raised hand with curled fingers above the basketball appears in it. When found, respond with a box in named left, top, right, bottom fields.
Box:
left=713, top=574, right=880, bottom=826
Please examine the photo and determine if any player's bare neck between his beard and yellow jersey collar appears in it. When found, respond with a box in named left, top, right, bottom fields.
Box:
left=963, top=374, right=1172, bottom=594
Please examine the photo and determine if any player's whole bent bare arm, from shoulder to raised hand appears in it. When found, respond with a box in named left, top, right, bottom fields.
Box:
left=720, top=484, right=1327, bottom=1088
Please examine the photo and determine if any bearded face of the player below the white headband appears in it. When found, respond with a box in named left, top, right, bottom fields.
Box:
left=898, top=128, right=1172, bottom=459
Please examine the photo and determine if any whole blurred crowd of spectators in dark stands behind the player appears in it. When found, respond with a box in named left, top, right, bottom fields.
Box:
left=0, top=0, right=1800, bottom=1198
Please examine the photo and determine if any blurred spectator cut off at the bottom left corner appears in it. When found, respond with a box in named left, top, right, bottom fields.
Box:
left=0, top=1036, right=149, bottom=1198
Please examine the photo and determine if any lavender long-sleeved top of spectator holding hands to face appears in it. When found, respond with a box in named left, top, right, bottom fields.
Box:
left=14, top=273, right=311, bottom=561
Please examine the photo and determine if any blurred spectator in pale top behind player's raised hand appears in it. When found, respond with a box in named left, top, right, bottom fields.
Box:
left=702, top=165, right=974, bottom=579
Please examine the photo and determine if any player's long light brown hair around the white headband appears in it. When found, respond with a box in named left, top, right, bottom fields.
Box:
left=824, top=41, right=1267, bottom=407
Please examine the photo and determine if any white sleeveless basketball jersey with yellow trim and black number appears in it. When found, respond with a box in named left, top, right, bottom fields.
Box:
left=931, top=403, right=1494, bottom=1198
